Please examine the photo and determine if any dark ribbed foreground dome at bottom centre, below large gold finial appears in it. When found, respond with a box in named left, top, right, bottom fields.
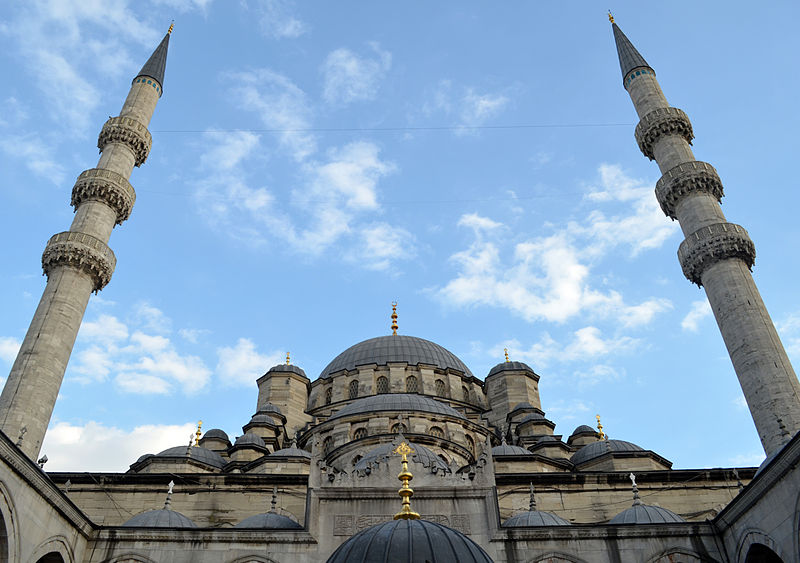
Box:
left=328, top=520, right=492, bottom=563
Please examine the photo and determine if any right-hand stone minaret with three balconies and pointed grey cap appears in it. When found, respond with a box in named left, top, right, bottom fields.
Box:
left=609, top=14, right=800, bottom=455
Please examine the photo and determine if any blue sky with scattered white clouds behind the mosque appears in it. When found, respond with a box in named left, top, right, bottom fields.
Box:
left=0, top=0, right=800, bottom=471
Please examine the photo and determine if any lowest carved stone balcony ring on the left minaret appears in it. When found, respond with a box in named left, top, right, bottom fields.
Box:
left=42, top=231, right=117, bottom=293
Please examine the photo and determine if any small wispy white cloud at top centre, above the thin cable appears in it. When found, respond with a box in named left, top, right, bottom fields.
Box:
left=322, top=43, right=392, bottom=105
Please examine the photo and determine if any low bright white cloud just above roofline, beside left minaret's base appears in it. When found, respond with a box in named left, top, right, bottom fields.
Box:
left=42, top=421, right=195, bottom=474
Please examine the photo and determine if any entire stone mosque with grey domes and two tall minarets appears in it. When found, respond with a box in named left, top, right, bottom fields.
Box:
left=0, top=13, right=800, bottom=563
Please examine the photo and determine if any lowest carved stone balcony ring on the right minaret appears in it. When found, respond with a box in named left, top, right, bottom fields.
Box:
left=678, top=223, right=756, bottom=286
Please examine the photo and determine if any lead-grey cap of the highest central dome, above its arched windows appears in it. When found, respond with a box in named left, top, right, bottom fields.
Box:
left=320, top=334, right=472, bottom=378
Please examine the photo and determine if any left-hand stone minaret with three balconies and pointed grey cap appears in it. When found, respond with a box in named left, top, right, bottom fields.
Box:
left=0, top=26, right=172, bottom=460
